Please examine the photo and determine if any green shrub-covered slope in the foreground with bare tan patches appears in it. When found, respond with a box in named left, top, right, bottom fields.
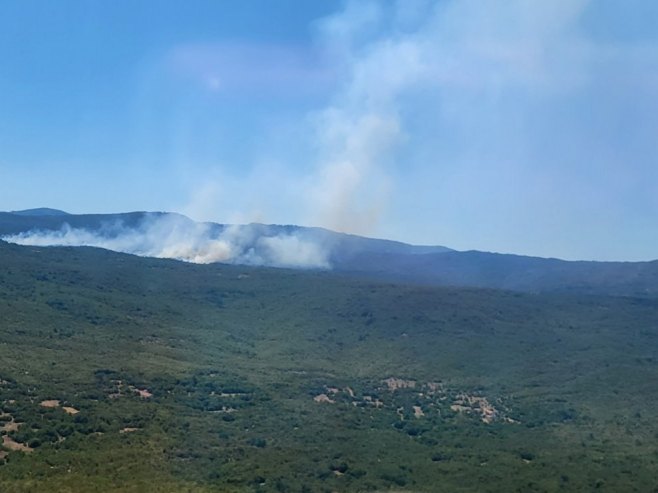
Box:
left=0, top=242, right=658, bottom=493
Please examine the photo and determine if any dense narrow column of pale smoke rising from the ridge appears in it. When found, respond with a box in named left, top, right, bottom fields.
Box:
left=307, top=2, right=410, bottom=234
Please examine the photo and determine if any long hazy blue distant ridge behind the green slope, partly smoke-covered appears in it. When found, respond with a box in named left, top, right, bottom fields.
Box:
left=0, top=208, right=658, bottom=297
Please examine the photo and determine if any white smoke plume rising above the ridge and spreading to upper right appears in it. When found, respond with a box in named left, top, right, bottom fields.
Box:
left=309, top=0, right=589, bottom=238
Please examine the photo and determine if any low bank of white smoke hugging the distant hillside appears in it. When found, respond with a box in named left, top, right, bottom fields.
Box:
left=2, top=214, right=330, bottom=269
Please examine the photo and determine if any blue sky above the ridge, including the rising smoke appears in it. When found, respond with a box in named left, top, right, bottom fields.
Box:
left=0, top=0, right=658, bottom=260
